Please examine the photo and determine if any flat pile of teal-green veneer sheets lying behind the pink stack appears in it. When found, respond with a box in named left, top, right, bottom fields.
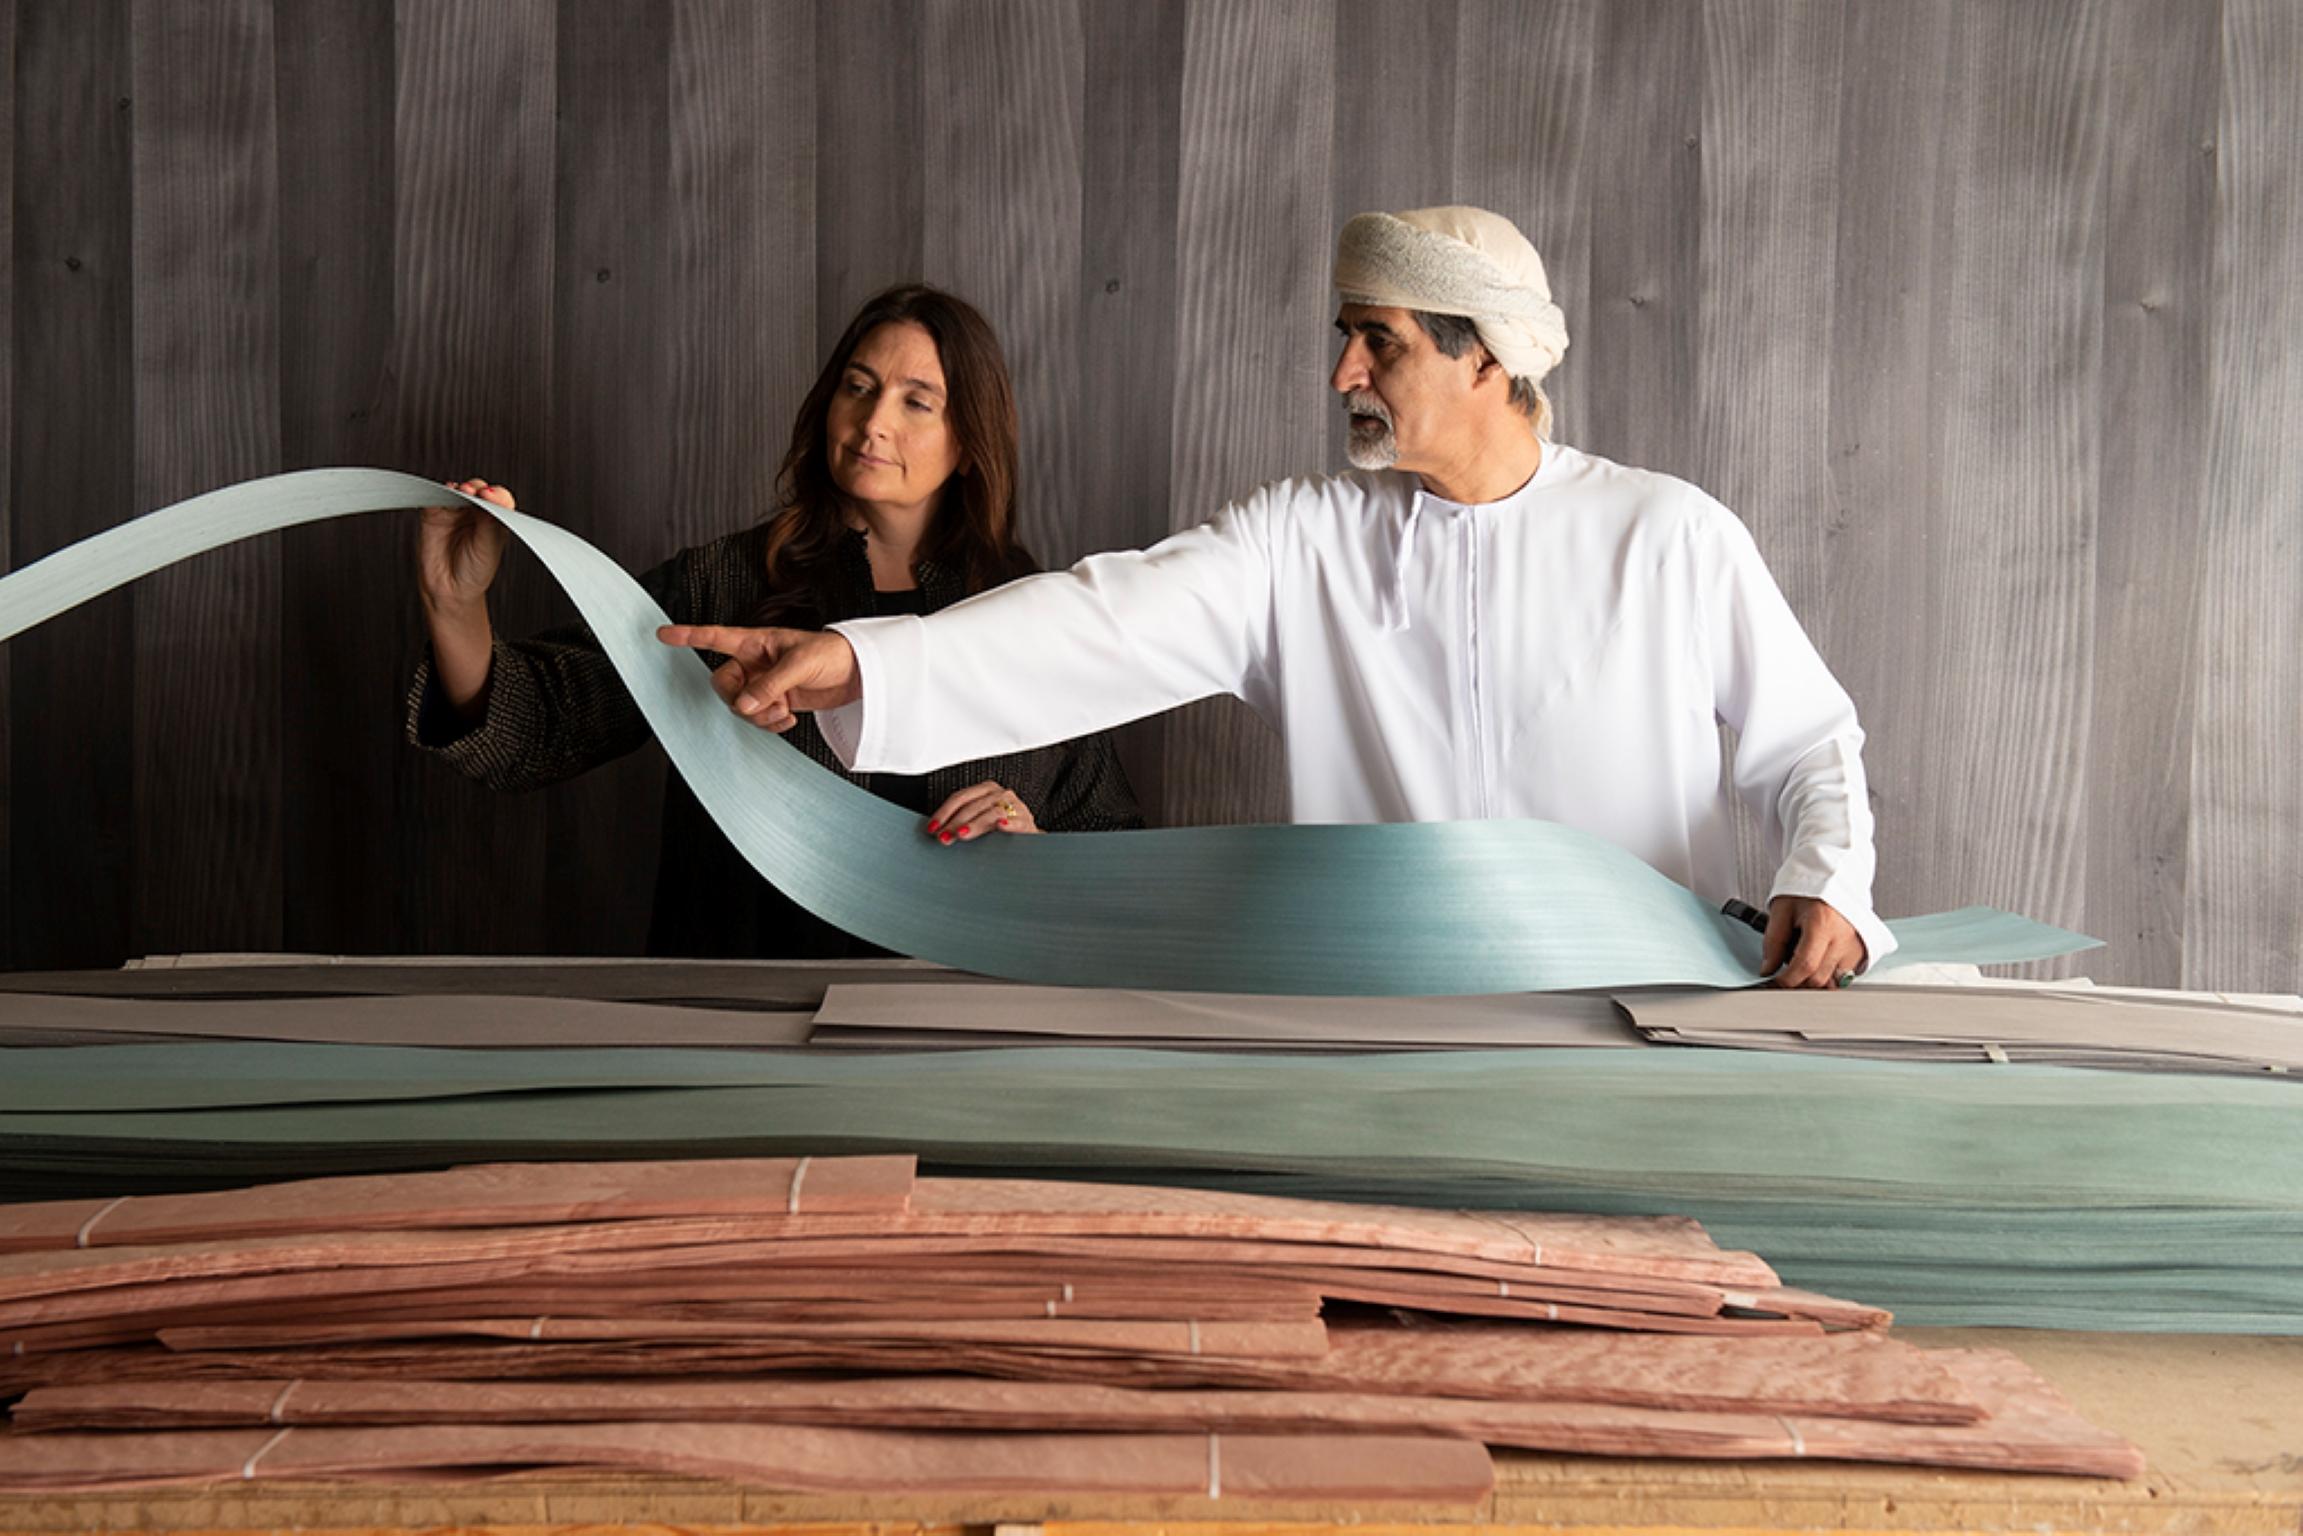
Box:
left=0, top=1043, right=2303, bottom=1333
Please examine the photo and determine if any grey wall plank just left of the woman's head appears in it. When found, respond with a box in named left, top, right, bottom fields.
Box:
left=661, top=0, right=820, bottom=550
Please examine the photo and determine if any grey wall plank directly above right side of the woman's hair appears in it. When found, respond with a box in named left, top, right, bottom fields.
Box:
left=921, top=0, right=1082, bottom=567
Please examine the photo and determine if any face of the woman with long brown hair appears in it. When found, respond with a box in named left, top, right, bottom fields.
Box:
left=824, top=320, right=960, bottom=511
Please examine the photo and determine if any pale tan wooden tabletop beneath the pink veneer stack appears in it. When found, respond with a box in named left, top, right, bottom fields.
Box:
left=0, top=1329, right=2303, bottom=1536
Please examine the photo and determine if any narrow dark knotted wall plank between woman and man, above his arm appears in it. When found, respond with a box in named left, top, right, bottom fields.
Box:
left=1077, top=0, right=1186, bottom=822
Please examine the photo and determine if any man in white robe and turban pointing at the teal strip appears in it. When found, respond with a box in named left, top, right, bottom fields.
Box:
left=663, top=207, right=1895, bottom=986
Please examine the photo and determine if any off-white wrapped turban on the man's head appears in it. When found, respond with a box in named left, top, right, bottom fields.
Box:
left=1336, top=207, right=1568, bottom=385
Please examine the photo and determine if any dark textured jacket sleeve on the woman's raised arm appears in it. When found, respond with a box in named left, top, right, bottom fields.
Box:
left=408, top=546, right=719, bottom=790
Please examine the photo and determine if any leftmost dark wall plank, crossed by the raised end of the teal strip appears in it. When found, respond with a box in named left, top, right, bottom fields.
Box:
left=9, top=0, right=136, bottom=967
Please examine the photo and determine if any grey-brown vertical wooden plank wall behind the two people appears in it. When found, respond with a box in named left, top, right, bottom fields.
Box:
left=0, top=0, right=2303, bottom=990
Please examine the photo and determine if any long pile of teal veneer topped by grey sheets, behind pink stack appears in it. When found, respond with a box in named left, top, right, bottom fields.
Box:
left=0, top=958, right=2303, bottom=1333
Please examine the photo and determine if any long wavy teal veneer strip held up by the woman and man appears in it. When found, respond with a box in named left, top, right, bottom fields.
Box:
left=0, top=470, right=2096, bottom=995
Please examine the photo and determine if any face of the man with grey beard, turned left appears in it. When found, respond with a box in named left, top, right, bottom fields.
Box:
left=1329, top=304, right=1479, bottom=472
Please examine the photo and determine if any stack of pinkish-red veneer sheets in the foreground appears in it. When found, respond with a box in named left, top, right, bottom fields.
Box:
left=0, top=1156, right=2142, bottom=1506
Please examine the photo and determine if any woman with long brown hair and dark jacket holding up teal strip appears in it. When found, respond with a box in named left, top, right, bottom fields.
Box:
left=408, top=286, right=1142, bottom=958
